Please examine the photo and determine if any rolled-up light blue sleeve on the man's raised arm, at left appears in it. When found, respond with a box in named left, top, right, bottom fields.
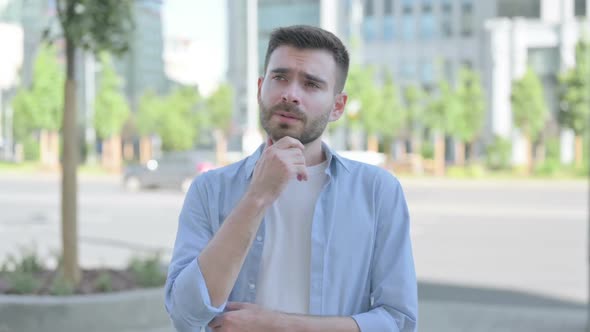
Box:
left=165, top=175, right=226, bottom=332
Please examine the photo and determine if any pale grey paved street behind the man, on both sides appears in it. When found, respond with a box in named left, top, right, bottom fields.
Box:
left=0, top=173, right=588, bottom=332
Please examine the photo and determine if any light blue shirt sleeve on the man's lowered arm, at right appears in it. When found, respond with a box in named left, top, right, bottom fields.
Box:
left=352, top=173, right=418, bottom=332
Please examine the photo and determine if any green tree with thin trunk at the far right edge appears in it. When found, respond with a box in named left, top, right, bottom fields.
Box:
left=558, top=40, right=590, bottom=167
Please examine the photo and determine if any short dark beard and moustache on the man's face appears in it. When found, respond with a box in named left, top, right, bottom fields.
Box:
left=258, top=100, right=330, bottom=145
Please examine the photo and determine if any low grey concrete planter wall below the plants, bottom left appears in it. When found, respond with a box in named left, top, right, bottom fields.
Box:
left=0, top=288, right=173, bottom=332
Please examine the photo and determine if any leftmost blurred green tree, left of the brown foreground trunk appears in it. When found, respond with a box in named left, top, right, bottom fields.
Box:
left=13, top=43, right=64, bottom=168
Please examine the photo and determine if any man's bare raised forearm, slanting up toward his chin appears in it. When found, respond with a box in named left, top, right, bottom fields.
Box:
left=198, top=194, right=266, bottom=306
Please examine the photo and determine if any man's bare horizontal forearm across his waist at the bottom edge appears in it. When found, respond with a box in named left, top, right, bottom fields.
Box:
left=280, top=314, right=360, bottom=332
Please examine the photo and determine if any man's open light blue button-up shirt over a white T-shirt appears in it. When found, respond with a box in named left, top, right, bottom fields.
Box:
left=165, top=144, right=418, bottom=332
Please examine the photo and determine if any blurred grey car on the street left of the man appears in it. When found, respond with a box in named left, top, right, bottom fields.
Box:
left=123, top=151, right=215, bottom=192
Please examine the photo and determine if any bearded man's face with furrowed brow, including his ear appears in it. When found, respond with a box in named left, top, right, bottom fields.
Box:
left=258, top=46, right=346, bottom=144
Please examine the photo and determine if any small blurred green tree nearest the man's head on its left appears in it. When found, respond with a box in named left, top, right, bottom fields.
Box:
left=206, top=84, right=233, bottom=165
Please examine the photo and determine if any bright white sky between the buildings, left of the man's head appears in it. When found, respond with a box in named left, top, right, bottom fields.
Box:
left=163, top=0, right=228, bottom=94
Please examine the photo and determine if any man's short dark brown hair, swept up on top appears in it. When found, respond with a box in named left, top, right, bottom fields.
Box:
left=264, top=25, right=349, bottom=92
